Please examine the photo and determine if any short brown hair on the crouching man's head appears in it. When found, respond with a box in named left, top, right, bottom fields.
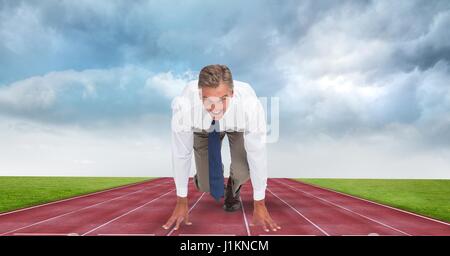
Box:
left=198, top=64, right=233, bottom=89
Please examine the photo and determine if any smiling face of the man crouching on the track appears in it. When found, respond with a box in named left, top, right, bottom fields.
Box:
left=201, top=83, right=233, bottom=120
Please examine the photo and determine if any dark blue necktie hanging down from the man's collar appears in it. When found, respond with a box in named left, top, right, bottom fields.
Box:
left=208, top=120, right=224, bottom=201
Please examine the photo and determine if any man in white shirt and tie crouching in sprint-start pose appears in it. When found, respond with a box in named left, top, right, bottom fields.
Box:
left=163, top=65, right=280, bottom=231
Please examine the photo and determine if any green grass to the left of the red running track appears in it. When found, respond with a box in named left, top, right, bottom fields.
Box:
left=0, top=176, right=150, bottom=212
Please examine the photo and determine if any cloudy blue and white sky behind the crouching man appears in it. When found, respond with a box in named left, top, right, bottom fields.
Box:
left=0, top=0, right=450, bottom=179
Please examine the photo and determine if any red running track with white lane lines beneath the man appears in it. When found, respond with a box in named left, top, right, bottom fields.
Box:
left=0, top=178, right=450, bottom=236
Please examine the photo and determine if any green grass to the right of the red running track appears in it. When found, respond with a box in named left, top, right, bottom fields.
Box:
left=298, top=179, right=450, bottom=222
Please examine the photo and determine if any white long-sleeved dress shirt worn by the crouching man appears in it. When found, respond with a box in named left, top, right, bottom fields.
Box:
left=172, top=80, right=267, bottom=200
